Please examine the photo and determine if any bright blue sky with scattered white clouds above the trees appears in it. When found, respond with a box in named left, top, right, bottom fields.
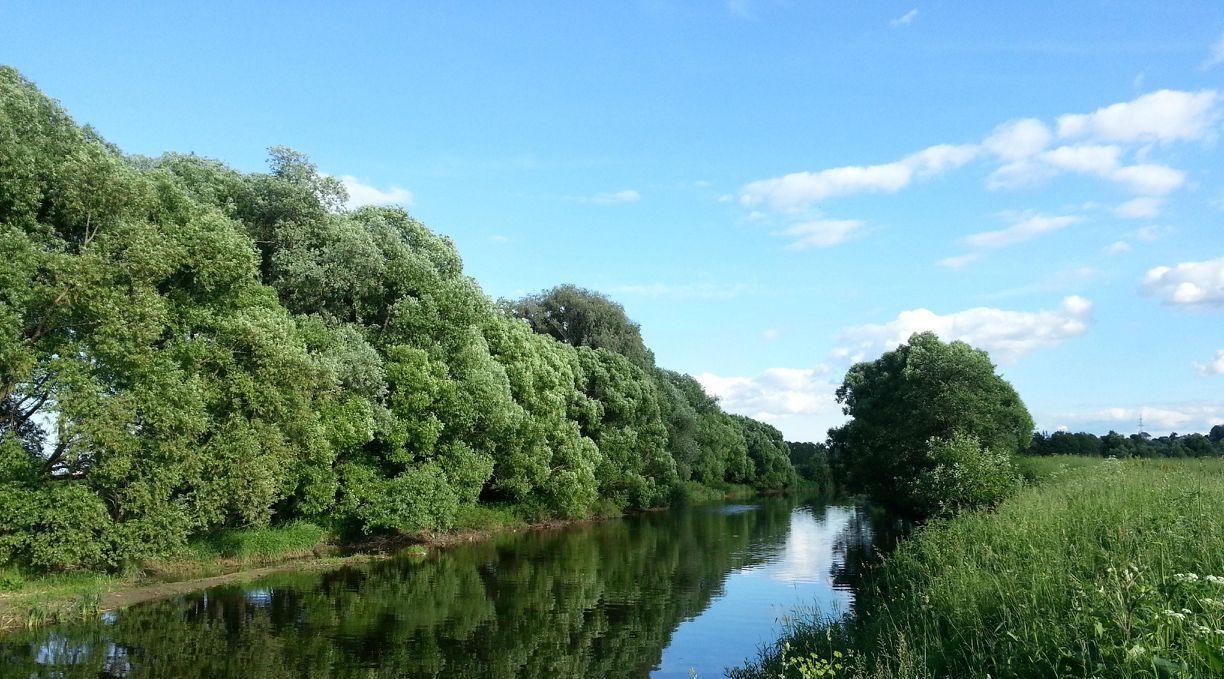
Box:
left=0, top=0, right=1224, bottom=440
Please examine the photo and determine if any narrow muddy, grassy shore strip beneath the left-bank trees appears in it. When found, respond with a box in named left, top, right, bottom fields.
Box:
left=0, top=486, right=783, bottom=631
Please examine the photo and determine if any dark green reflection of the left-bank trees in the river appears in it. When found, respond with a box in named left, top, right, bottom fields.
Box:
left=0, top=499, right=793, bottom=679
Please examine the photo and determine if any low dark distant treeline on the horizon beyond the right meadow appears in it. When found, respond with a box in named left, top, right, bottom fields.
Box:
left=1028, top=425, right=1224, bottom=458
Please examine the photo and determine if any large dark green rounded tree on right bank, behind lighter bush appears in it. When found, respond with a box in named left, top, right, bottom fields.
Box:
left=830, top=333, right=1033, bottom=511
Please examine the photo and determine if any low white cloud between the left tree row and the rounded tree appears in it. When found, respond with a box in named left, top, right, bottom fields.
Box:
left=695, top=366, right=845, bottom=440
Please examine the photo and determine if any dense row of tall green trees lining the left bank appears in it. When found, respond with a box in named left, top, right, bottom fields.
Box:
left=0, top=69, right=793, bottom=569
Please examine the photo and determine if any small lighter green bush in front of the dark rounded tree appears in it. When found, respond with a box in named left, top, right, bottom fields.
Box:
left=913, top=433, right=1018, bottom=516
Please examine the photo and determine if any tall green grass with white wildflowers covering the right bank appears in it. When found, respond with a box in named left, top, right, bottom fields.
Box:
left=733, top=460, right=1224, bottom=679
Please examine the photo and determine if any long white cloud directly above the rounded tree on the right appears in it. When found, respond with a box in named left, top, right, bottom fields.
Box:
left=837, top=295, right=1092, bottom=363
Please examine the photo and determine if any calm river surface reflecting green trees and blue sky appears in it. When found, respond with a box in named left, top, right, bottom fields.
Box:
left=0, top=498, right=892, bottom=679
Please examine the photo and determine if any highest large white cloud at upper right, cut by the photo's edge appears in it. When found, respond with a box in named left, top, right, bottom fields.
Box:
left=1058, top=89, right=1219, bottom=142
